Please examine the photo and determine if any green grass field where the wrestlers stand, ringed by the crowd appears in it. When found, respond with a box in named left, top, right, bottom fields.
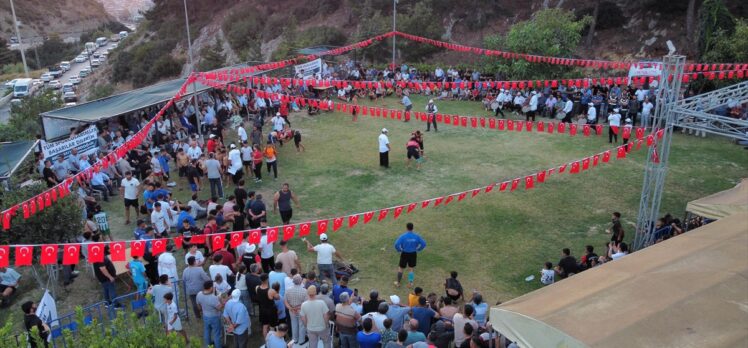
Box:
left=95, top=96, right=748, bottom=302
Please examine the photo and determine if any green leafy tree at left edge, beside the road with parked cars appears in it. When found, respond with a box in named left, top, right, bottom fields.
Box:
left=0, top=90, right=63, bottom=141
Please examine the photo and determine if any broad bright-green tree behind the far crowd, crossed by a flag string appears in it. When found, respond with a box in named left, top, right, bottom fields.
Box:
left=484, top=8, right=591, bottom=80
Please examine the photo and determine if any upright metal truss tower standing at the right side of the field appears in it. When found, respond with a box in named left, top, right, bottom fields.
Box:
left=633, top=55, right=686, bottom=250
